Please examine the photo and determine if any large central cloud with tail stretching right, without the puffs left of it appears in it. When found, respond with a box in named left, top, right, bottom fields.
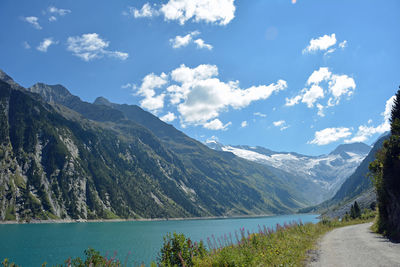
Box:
left=172, top=65, right=287, bottom=127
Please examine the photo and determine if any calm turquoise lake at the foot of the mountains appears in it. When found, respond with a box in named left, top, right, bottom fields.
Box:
left=0, top=214, right=318, bottom=266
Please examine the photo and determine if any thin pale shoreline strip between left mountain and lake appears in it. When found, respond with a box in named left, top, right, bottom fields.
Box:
left=0, top=213, right=317, bottom=225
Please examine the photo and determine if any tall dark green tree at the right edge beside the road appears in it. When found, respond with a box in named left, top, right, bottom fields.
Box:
left=369, top=90, right=400, bottom=240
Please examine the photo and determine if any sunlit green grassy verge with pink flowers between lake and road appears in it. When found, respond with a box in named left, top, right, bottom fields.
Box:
left=193, top=214, right=374, bottom=266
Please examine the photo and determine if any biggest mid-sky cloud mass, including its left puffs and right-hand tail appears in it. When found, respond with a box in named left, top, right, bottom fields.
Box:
left=130, top=64, right=287, bottom=130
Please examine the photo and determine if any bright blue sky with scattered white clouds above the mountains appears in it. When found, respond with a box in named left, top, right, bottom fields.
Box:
left=0, top=0, right=400, bottom=155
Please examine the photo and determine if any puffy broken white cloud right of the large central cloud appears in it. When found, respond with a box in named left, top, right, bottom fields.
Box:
left=285, top=67, right=356, bottom=117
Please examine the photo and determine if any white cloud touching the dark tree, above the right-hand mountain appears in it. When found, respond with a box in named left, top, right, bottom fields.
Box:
left=345, top=96, right=395, bottom=143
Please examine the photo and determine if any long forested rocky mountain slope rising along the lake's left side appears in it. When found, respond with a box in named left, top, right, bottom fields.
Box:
left=0, top=71, right=307, bottom=220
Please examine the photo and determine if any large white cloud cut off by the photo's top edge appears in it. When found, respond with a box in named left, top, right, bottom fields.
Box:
left=124, top=0, right=236, bottom=25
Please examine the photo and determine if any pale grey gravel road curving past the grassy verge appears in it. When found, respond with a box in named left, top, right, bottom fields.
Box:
left=309, top=223, right=400, bottom=267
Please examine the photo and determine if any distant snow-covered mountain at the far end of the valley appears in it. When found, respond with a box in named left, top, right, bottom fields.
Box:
left=206, top=140, right=371, bottom=201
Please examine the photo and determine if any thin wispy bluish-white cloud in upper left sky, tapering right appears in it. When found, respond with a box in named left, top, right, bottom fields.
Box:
left=67, top=33, right=129, bottom=61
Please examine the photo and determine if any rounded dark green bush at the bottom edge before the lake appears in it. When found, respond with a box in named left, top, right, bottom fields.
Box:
left=159, top=232, right=207, bottom=267
